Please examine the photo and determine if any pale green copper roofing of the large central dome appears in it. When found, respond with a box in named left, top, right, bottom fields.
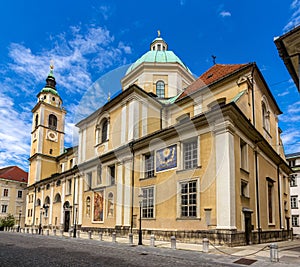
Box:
left=126, top=50, right=191, bottom=75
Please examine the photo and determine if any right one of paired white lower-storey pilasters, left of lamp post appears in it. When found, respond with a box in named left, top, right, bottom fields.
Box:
left=124, top=161, right=131, bottom=226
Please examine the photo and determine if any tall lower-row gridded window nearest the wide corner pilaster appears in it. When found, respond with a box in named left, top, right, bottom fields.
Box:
left=180, top=181, right=197, bottom=217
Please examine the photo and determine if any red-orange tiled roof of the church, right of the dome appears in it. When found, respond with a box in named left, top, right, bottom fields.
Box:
left=178, top=63, right=252, bottom=99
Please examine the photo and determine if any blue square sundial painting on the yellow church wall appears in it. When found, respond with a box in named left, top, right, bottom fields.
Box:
left=156, top=145, right=177, bottom=172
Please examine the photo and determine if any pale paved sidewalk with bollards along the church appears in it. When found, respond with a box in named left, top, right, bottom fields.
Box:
left=4, top=232, right=300, bottom=267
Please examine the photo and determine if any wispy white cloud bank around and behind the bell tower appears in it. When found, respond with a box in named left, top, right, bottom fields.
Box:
left=0, top=22, right=131, bottom=169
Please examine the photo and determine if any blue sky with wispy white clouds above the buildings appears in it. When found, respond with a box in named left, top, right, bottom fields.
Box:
left=0, top=0, right=300, bottom=170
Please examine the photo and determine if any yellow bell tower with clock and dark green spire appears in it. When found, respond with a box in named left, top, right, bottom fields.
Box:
left=28, top=63, right=66, bottom=185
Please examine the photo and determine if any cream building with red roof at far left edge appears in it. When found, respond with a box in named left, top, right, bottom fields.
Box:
left=0, top=166, right=28, bottom=227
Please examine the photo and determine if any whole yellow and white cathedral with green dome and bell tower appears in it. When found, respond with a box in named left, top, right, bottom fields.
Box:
left=26, top=35, right=292, bottom=246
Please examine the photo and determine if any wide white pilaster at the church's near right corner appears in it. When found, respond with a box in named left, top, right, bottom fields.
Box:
left=215, top=122, right=236, bottom=229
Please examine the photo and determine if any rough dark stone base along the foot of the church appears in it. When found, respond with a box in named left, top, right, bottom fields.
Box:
left=81, top=227, right=293, bottom=247
